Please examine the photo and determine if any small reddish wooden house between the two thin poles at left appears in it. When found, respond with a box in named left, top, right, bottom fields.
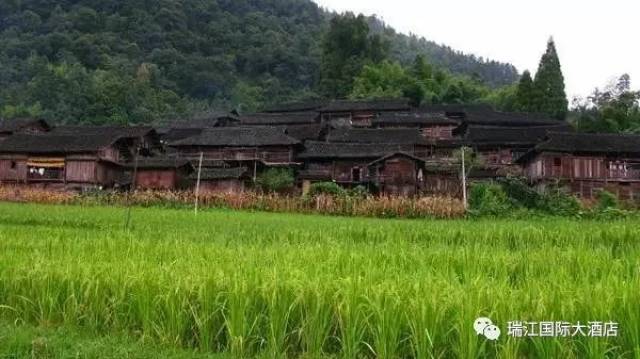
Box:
left=126, top=157, right=194, bottom=190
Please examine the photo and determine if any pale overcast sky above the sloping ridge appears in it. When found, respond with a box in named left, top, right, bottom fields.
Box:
left=315, top=0, right=640, bottom=99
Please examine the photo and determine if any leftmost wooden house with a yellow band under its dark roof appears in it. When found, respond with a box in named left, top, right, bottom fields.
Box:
left=0, top=133, right=131, bottom=188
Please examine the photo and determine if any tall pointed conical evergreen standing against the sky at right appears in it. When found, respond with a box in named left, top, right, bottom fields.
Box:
left=533, top=38, right=568, bottom=120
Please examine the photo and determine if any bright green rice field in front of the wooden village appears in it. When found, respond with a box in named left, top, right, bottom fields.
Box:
left=0, top=204, right=640, bottom=358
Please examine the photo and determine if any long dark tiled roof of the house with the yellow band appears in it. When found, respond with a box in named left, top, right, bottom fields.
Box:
left=0, top=133, right=121, bottom=154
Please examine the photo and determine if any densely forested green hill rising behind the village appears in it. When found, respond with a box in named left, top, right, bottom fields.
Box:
left=0, top=0, right=518, bottom=123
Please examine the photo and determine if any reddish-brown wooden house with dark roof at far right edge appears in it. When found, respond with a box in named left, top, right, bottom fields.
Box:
left=518, top=132, right=640, bottom=199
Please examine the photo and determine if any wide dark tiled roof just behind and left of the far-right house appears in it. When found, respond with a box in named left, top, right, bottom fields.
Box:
left=463, top=124, right=573, bottom=147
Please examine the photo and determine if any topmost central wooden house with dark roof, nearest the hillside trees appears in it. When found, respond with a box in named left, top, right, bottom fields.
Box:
left=318, top=99, right=411, bottom=128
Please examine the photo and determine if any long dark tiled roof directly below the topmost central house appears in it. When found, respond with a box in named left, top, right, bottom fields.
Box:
left=327, top=128, right=428, bottom=145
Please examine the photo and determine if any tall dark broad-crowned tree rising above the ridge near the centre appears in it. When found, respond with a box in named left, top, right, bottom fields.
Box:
left=320, top=13, right=388, bottom=98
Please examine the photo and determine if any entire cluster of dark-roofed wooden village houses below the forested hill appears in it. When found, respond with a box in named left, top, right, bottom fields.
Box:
left=0, top=99, right=640, bottom=199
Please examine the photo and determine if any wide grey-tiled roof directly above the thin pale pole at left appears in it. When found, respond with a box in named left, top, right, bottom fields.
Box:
left=170, top=127, right=300, bottom=147
